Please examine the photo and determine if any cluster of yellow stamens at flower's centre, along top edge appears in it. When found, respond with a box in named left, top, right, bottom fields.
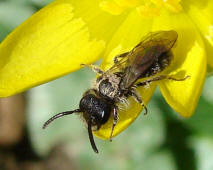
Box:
left=99, top=0, right=182, bottom=17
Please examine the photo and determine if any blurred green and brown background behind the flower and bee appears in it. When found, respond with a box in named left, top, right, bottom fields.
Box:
left=0, top=0, right=213, bottom=170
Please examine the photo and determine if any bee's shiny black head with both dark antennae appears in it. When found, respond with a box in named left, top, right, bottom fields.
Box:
left=43, top=89, right=112, bottom=153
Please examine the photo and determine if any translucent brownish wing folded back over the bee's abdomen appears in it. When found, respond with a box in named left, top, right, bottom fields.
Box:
left=121, top=30, right=178, bottom=89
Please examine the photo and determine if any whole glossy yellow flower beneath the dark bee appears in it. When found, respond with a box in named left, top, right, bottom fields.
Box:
left=0, top=0, right=213, bottom=139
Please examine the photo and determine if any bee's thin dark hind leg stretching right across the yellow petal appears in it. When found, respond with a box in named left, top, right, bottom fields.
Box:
left=135, top=75, right=190, bottom=87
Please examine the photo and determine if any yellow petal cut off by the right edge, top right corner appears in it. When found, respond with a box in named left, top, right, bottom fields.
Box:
left=183, top=0, right=213, bottom=68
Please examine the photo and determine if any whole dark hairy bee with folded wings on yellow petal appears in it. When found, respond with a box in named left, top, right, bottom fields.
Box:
left=43, top=30, right=187, bottom=153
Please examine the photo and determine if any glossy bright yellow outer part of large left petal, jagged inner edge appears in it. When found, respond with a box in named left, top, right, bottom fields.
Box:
left=0, top=1, right=104, bottom=97
